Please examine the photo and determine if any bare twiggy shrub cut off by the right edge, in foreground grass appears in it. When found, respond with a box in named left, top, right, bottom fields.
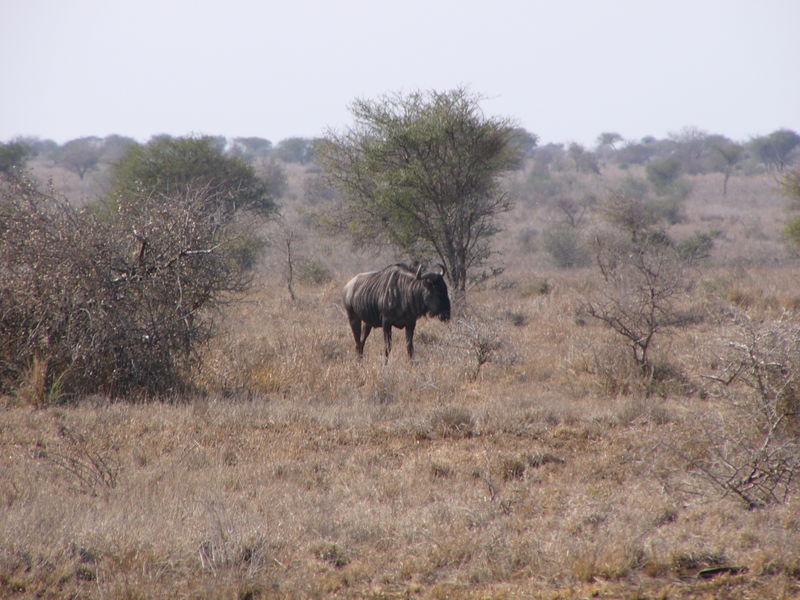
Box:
left=693, top=313, right=800, bottom=509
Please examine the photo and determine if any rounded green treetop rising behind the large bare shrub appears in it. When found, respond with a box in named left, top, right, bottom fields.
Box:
left=110, top=136, right=276, bottom=215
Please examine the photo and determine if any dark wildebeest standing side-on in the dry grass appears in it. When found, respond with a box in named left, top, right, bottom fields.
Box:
left=344, top=263, right=450, bottom=361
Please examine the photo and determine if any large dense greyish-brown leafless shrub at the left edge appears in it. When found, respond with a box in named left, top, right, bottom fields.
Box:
left=0, top=173, right=253, bottom=403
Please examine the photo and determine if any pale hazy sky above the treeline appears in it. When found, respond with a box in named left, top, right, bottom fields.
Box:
left=0, top=0, right=800, bottom=145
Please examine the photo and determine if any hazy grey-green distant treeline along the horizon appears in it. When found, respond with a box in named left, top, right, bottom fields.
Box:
left=0, top=127, right=800, bottom=179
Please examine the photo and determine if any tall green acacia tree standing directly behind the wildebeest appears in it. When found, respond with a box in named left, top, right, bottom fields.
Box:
left=316, top=88, right=521, bottom=306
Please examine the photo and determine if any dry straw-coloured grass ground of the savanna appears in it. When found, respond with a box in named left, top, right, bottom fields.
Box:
left=0, top=159, right=800, bottom=599
